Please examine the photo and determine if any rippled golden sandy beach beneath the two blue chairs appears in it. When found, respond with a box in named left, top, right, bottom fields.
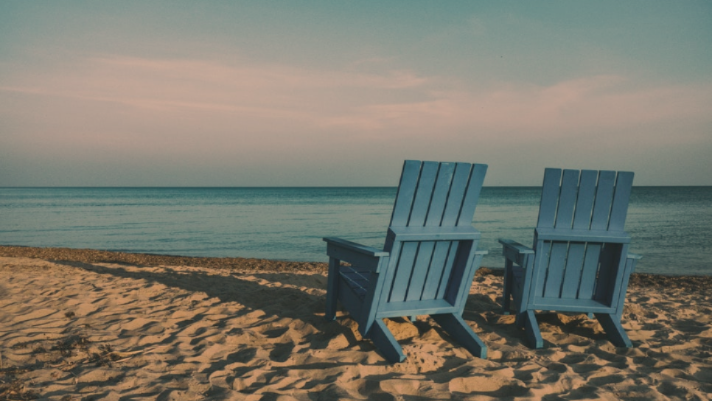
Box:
left=0, top=247, right=712, bottom=400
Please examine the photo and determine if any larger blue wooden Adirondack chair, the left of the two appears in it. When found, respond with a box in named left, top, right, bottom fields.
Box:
left=324, top=160, right=487, bottom=363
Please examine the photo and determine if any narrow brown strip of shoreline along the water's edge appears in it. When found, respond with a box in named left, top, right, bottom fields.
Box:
left=0, top=245, right=712, bottom=290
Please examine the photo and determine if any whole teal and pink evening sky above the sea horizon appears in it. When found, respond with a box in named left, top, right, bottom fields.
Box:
left=0, top=0, right=712, bottom=186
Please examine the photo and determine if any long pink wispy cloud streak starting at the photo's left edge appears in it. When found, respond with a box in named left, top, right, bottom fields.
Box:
left=0, top=56, right=427, bottom=121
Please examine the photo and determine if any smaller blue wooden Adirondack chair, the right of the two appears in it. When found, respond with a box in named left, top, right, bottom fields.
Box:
left=499, top=168, right=641, bottom=348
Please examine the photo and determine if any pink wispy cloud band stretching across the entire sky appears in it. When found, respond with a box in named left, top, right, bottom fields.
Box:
left=0, top=56, right=712, bottom=135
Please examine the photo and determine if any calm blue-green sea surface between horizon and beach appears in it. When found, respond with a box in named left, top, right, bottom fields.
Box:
left=0, top=187, right=712, bottom=275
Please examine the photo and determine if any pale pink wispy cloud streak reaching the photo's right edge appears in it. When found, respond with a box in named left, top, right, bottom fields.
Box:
left=329, top=76, right=712, bottom=138
